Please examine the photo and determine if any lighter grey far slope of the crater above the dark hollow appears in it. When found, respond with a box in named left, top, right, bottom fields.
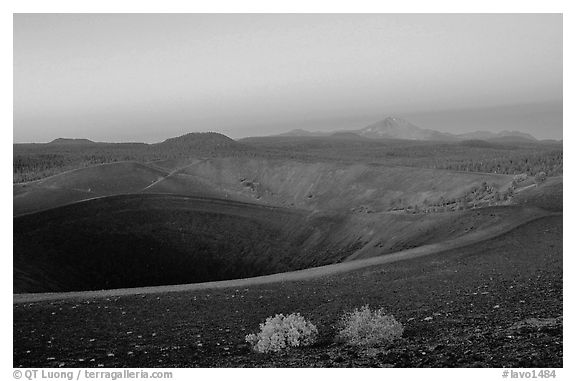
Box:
left=13, top=157, right=512, bottom=216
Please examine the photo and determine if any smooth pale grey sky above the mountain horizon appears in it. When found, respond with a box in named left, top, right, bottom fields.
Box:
left=14, top=14, right=562, bottom=142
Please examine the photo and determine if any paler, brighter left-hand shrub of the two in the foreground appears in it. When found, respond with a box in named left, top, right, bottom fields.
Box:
left=246, top=313, right=318, bottom=353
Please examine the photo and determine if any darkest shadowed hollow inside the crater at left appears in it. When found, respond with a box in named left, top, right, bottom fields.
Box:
left=14, top=194, right=354, bottom=293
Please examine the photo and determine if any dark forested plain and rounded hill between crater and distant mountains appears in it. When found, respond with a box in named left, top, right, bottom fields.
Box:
left=13, top=133, right=563, bottom=183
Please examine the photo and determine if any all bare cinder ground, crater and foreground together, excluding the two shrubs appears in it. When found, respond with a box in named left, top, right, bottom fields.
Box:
left=13, top=134, right=562, bottom=367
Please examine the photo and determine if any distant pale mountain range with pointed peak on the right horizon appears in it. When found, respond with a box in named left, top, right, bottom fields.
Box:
left=278, top=116, right=537, bottom=143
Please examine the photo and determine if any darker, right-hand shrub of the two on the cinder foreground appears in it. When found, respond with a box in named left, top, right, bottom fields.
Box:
left=338, top=305, right=404, bottom=346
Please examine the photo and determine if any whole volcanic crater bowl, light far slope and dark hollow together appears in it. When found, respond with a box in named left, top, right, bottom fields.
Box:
left=14, top=158, right=528, bottom=293
